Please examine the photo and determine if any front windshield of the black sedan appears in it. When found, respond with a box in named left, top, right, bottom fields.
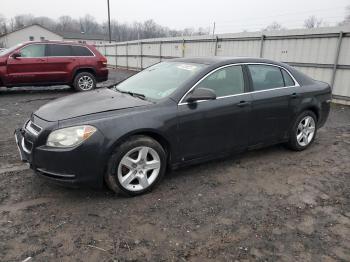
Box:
left=116, top=62, right=206, bottom=100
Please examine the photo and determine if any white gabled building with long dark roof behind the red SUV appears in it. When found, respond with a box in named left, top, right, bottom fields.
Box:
left=0, top=24, right=113, bottom=48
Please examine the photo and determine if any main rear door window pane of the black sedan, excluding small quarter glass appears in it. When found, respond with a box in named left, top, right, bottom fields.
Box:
left=248, top=65, right=284, bottom=91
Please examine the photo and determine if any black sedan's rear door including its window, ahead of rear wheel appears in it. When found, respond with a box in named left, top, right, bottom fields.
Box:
left=247, top=64, right=296, bottom=145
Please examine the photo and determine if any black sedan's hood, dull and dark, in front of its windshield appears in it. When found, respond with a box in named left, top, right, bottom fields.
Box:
left=34, top=88, right=151, bottom=121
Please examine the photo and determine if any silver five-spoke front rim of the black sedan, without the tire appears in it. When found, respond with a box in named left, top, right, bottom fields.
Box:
left=118, top=146, right=161, bottom=191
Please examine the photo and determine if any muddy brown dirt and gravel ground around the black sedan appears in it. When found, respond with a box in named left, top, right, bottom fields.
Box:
left=0, top=71, right=350, bottom=261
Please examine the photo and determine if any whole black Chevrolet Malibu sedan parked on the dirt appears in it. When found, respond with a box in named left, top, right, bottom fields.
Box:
left=15, top=57, right=331, bottom=195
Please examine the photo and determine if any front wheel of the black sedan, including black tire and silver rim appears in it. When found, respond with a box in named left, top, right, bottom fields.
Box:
left=105, top=136, right=167, bottom=196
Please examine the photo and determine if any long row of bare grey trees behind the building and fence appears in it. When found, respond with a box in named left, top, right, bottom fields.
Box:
left=0, top=14, right=209, bottom=41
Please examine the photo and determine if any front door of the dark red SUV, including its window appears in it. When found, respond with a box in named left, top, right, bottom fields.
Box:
left=7, top=43, right=48, bottom=85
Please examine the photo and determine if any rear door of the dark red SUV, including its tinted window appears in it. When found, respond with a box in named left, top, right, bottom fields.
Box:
left=47, top=44, right=79, bottom=83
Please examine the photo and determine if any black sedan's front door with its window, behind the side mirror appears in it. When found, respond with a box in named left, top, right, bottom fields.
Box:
left=178, top=65, right=251, bottom=161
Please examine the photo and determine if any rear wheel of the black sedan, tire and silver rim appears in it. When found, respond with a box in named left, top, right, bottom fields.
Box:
left=288, top=110, right=317, bottom=151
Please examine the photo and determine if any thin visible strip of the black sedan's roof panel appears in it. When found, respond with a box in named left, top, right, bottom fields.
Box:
left=170, top=56, right=284, bottom=66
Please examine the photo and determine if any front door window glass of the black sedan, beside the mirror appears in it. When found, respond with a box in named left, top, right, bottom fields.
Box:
left=198, top=66, right=244, bottom=97
